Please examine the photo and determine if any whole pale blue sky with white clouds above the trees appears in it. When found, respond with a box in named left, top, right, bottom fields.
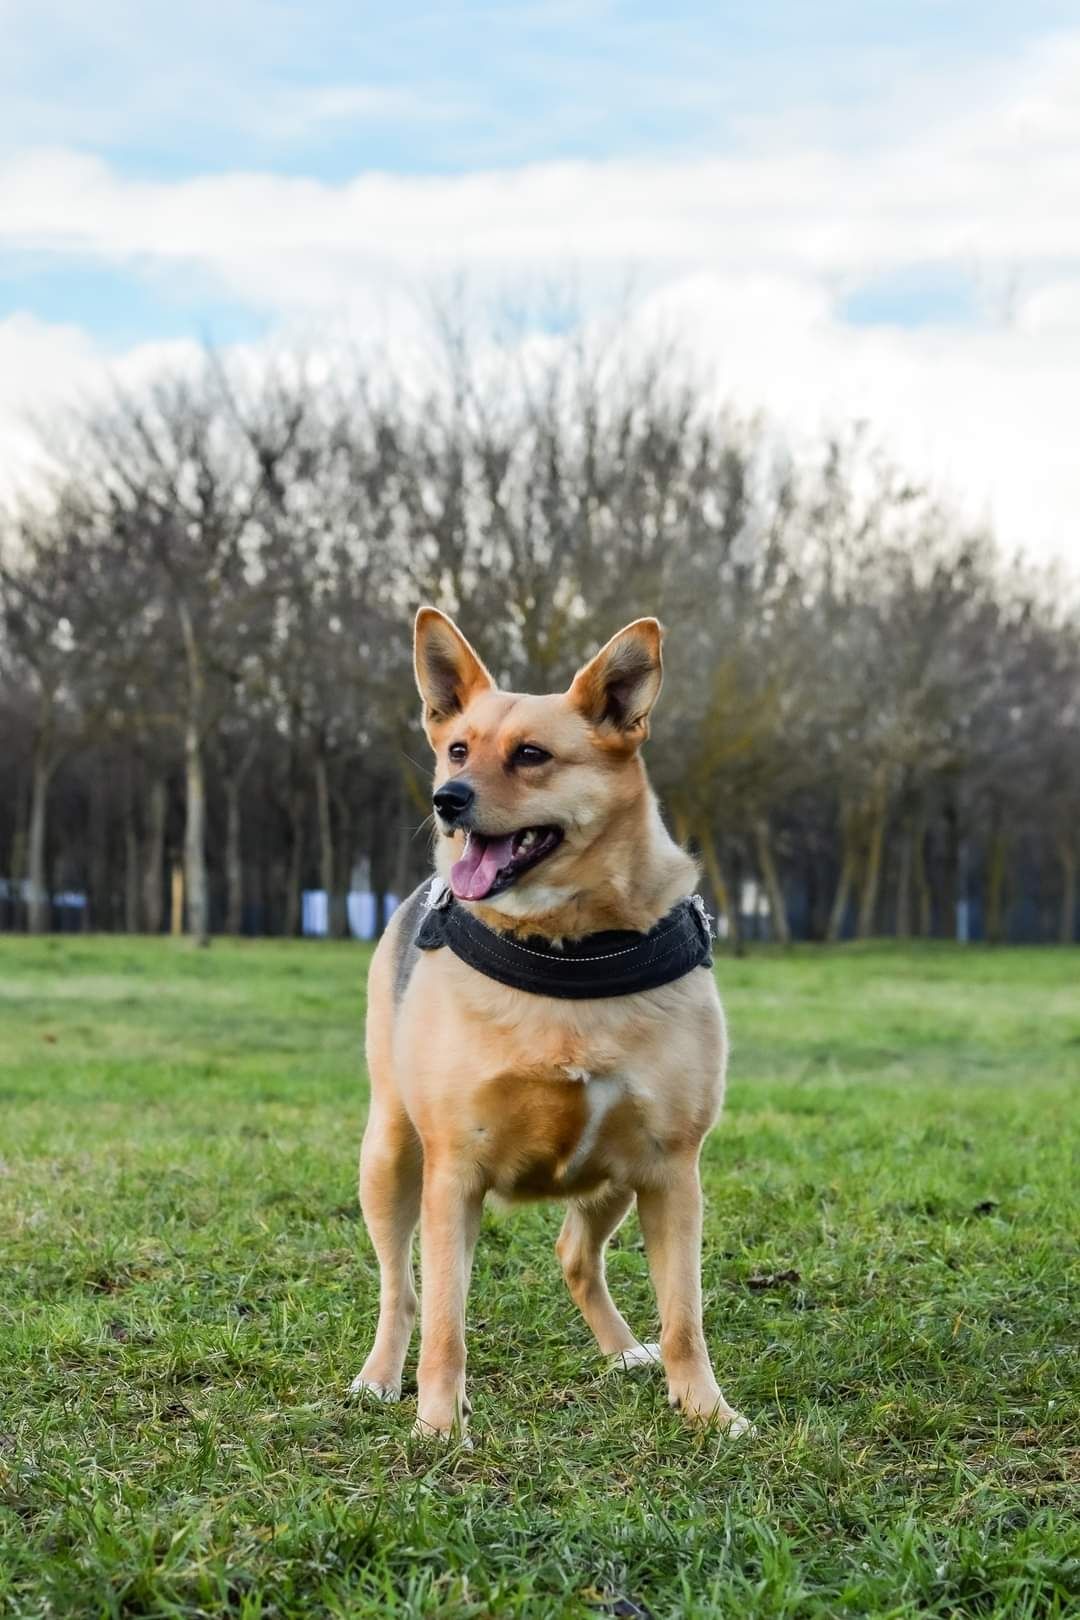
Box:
left=0, top=0, right=1080, bottom=567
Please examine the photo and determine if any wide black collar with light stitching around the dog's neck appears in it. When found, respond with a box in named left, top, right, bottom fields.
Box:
left=416, top=878, right=712, bottom=1001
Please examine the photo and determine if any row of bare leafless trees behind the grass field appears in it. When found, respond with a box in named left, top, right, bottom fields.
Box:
left=0, top=334, right=1080, bottom=946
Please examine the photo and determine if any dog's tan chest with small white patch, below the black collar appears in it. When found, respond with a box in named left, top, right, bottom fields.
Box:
left=409, top=953, right=724, bottom=1197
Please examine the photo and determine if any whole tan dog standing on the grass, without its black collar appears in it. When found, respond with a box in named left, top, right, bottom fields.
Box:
left=353, top=608, right=746, bottom=1434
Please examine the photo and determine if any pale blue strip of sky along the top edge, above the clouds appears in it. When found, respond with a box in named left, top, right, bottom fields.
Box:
left=0, top=0, right=1077, bottom=180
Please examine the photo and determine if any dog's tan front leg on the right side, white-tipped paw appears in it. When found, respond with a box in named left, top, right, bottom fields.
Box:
left=638, top=1155, right=750, bottom=1434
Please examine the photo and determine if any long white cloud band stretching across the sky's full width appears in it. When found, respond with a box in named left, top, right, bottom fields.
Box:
left=0, top=34, right=1080, bottom=291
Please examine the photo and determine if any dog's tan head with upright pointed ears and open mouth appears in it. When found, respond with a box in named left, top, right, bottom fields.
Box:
left=415, top=608, right=662, bottom=917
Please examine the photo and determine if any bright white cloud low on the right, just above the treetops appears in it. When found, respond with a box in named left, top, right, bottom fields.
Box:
left=636, top=275, right=1080, bottom=570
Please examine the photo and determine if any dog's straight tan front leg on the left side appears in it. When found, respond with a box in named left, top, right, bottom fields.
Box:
left=416, top=1160, right=484, bottom=1435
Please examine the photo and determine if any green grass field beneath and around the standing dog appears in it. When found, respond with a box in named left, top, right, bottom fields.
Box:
left=0, top=938, right=1080, bottom=1620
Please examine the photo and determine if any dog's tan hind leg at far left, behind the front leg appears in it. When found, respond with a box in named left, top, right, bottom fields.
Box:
left=351, top=1098, right=423, bottom=1401
